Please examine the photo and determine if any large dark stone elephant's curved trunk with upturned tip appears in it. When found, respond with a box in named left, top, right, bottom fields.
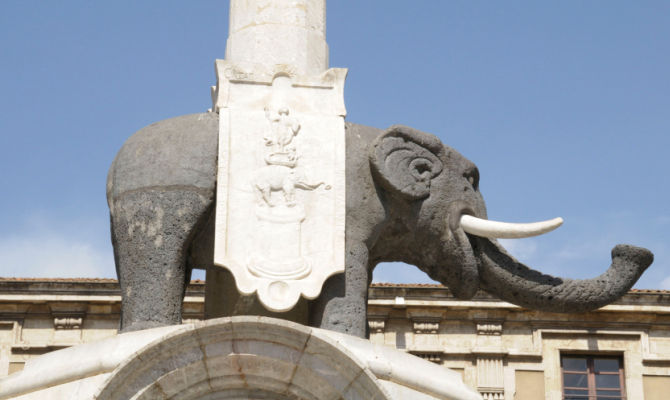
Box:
left=476, top=238, right=654, bottom=312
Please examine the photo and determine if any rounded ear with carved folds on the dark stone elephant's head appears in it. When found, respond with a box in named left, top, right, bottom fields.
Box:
left=370, top=125, right=444, bottom=200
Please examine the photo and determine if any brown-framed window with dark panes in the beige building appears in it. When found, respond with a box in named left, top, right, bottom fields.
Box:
left=561, top=355, right=626, bottom=400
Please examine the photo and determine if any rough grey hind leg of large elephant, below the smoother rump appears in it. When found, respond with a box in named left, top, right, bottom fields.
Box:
left=111, top=188, right=212, bottom=332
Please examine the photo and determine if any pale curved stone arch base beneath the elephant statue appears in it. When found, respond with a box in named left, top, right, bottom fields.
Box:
left=0, top=317, right=481, bottom=400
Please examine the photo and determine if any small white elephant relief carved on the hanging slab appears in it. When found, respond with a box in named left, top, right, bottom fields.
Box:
left=254, top=165, right=330, bottom=207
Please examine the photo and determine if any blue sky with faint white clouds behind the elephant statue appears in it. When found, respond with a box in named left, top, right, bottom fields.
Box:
left=0, top=0, right=670, bottom=289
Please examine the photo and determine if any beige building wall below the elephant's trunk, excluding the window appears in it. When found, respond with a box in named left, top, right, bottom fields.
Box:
left=368, top=284, right=670, bottom=400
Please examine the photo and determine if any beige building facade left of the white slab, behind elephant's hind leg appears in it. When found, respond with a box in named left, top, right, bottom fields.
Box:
left=0, top=278, right=204, bottom=377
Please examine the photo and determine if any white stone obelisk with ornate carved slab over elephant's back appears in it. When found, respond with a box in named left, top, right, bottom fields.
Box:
left=212, top=0, right=347, bottom=311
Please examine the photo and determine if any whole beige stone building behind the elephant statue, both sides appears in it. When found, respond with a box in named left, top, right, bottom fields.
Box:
left=0, top=278, right=670, bottom=400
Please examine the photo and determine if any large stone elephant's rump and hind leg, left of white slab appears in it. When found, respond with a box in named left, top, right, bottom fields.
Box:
left=107, top=114, right=218, bottom=331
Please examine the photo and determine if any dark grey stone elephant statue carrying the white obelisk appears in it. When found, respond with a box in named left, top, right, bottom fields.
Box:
left=107, top=113, right=653, bottom=337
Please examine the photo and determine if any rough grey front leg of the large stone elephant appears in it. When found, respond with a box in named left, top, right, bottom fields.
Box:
left=310, top=243, right=370, bottom=338
